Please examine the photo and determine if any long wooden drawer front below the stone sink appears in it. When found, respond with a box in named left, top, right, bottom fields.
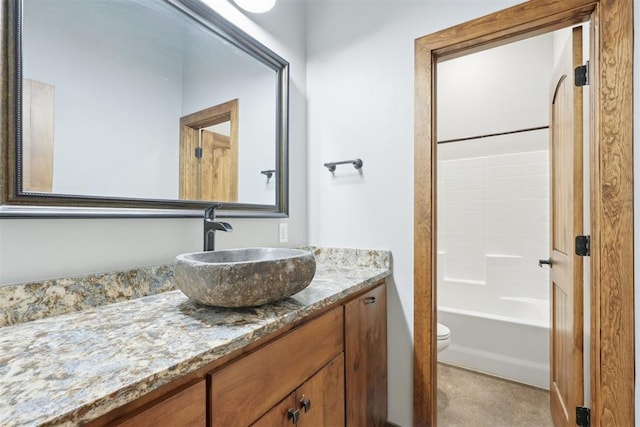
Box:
left=211, top=307, right=344, bottom=427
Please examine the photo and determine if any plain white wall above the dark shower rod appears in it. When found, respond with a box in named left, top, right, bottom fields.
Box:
left=437, top=34, right=553, bottom=141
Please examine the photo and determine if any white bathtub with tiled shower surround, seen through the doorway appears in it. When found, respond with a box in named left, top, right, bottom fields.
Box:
left=437, top=144, right=550, bottom=389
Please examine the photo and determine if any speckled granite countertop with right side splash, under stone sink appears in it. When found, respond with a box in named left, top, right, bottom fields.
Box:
left=0, top=248, right=391, bottom=426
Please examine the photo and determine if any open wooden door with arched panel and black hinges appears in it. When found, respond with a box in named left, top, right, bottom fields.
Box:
left=550, top=27, right=584, bottom=426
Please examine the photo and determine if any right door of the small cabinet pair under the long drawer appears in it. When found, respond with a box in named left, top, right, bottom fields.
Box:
left=296, top=353, right=344, bottom=427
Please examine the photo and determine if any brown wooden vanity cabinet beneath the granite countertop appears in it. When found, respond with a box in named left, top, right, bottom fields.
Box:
left=102, top=282, right=387, bottom=427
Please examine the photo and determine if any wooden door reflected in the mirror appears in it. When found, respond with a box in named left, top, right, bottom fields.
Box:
left=198, top=129, right=238, bottom=202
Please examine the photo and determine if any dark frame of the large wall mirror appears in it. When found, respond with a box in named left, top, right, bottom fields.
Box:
left=0, top=0, right=289, bottom=218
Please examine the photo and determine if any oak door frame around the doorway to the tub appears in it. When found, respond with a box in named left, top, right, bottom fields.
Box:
left=413, top=0, right=635, bottom=426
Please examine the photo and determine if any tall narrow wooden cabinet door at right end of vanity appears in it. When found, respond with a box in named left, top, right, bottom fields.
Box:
left=344, top=284, right=387, bottom=427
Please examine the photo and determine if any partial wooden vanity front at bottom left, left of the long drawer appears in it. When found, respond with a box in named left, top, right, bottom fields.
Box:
left=118, top=380, right=207, bottom=427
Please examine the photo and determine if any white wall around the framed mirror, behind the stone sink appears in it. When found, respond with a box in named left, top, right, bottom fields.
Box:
left=0, top=1, right=307, bottom=285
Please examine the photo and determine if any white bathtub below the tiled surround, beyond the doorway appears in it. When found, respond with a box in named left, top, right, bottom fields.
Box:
left=438, top=295, right=549, bottom=389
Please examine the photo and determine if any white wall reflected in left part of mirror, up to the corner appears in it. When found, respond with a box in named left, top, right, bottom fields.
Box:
left=23, top=1, right=182, bottom=198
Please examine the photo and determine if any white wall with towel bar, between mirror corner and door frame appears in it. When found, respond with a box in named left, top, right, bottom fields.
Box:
left=307, top=1, right=519, bottom=425
